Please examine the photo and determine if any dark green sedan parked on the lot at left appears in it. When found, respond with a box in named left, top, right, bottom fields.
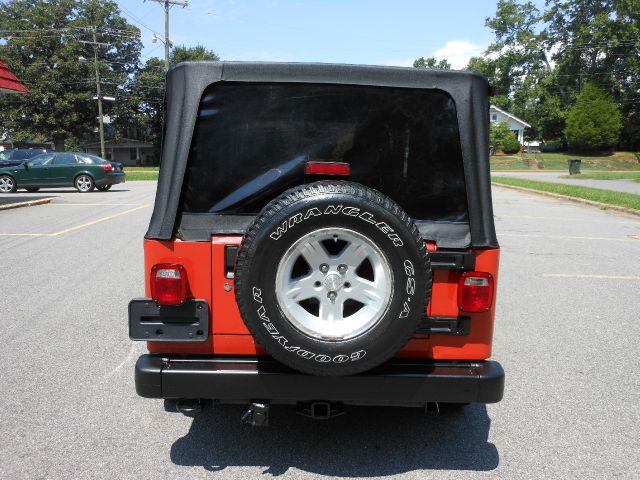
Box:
left=0, top=152, right=125, bottom=193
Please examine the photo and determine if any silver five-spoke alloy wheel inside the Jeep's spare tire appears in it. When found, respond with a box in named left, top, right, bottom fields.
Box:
left=276, top=228, right=393, bottom=341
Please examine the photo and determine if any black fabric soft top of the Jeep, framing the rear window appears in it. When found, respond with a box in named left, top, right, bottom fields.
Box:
left=146, top=62, right=498, bottom=248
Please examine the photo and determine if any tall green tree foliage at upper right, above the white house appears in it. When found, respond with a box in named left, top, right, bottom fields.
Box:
left=476, top=0, right=640, bottom=148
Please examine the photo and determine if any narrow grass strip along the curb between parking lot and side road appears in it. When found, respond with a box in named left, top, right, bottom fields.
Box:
left=491, top=173, right=640, bottom=210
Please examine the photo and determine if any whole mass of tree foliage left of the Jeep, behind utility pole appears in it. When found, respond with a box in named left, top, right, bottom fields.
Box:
left=0, top=0, right=218, bottom=161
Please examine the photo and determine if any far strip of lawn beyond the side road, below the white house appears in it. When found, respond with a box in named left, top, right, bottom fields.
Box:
left=491, top=152, right=640, bottom=171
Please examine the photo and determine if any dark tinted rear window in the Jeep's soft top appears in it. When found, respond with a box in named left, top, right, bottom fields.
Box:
left=181, top=82, right=468, bottom=223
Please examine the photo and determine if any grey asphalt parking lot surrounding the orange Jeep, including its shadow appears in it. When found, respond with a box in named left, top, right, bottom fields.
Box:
left=0, top=182, right=640, bottom=479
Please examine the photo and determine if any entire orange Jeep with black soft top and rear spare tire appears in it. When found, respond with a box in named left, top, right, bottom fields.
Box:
left=129, top=62, right=504, bottom=425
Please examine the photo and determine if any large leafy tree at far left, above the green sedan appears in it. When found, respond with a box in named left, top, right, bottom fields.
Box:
left=0, top=0, right=142, bottom=150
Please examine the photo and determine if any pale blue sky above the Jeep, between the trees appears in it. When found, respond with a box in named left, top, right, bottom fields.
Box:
left=118, top=0, right=538, bottom=68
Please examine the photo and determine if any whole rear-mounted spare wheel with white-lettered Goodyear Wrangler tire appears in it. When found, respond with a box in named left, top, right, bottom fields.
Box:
left=235, top=181, right=431, bottom=375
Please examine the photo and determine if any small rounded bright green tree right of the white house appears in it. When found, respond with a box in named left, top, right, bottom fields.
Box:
left=565, top=83, right=622, bottom=151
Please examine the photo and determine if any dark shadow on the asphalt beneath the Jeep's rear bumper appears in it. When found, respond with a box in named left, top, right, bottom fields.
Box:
left=171, top=405, right=500, bottom=477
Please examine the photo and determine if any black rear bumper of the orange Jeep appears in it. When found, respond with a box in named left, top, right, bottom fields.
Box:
left=135, top=355, right=504, bottom=406
